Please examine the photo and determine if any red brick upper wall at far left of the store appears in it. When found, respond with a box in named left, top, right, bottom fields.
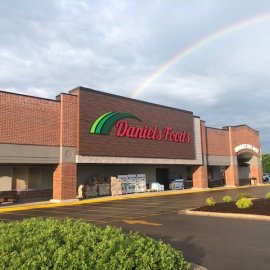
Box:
left=0, top=92, right=60, bottom=145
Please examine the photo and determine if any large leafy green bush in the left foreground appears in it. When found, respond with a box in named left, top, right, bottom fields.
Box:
left=0, top=218, right=189, bottom=270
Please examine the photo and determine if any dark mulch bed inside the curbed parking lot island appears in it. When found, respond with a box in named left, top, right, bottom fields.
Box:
left=193, top=199, right=270, bottom=216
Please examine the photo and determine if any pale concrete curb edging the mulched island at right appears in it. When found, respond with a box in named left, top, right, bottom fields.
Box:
left=178, top=208, right=270, bottom=221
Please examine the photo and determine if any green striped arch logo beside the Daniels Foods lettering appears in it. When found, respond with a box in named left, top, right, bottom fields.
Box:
left=90, top=112, right=141, bottom=135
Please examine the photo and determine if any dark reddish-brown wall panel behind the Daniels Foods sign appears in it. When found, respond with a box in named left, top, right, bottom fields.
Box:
left=75, top=90, right=195, bottom=159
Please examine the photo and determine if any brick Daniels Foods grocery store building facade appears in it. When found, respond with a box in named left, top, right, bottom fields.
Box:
left=0, top=87, right=262, bottom=201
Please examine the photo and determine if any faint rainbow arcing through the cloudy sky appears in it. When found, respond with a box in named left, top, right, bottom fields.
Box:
left=130, top=12, right=270, bottom=98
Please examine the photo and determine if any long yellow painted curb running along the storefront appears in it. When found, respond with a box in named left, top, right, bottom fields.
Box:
left=0, top=184, right=270, bottom=213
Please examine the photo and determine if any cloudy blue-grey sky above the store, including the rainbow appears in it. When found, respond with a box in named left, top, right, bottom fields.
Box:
left=0, top=0, right=270, bottom=153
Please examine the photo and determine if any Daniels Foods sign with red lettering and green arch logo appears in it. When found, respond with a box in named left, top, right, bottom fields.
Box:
left=90, top=112, right=191, bottom=143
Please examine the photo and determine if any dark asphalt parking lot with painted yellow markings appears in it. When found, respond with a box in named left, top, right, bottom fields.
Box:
left=0, top=186, right=270, bottom=270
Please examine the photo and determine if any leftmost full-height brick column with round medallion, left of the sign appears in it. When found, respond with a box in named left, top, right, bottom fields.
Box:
left=52, top=94, right=77, bottom=202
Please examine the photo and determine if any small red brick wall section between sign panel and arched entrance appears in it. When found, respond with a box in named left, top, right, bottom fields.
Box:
left=206, top=127, right=230, bottom=156
